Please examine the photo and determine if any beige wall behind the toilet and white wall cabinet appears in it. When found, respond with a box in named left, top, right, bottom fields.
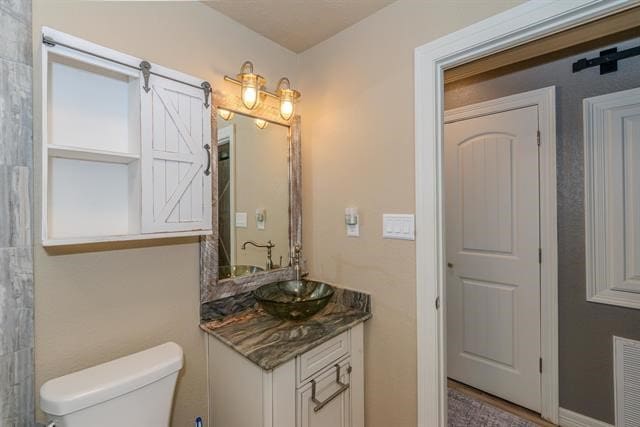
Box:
left=33, top=0, right=296, bottom=426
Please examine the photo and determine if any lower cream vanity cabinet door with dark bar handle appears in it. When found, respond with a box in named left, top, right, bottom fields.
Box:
left=296, top=358, right=352, bottom=427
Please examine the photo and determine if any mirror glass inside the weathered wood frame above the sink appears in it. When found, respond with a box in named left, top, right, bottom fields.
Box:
left=218, top=112, right=289, bottom=280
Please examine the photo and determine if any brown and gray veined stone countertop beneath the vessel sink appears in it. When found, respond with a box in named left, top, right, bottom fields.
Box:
left=200, top=287, right=372, bottom=370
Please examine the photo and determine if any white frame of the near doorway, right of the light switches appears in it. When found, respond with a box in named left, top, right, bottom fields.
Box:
left=414, top=0, right=640, bottom=427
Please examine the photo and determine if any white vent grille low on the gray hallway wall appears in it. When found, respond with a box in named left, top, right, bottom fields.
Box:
left=613, top=337, right=640, bottom=427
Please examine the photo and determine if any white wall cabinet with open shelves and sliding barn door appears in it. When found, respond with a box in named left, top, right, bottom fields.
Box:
left=42, top=28, right=212, bottom=246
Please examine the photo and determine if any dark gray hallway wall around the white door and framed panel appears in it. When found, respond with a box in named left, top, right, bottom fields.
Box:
left=445, top=34, right=640, bottom=424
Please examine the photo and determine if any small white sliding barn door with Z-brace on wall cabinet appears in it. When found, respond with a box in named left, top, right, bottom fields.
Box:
left=141, top=75, right=213, bottom=233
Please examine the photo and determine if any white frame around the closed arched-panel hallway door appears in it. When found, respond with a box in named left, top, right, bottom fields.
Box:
left=440, top=86, right=559, bottom=414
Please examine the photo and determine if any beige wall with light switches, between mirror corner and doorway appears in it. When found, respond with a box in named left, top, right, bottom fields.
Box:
left=300, top=0, right=518, bottom=427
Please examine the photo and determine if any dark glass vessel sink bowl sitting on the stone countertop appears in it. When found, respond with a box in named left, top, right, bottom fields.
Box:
left=253, top=280, right=333, bottom=320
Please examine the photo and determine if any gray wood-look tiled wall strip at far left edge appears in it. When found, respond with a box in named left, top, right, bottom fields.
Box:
left=0, top=0, right=34, bottom=427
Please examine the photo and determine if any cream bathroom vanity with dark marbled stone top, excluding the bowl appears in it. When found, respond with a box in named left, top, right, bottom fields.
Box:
left=201, top=288, right=371, bottom=427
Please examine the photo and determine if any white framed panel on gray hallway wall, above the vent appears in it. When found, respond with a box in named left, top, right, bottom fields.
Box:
left=583, top=88, right=640, bottom=309
